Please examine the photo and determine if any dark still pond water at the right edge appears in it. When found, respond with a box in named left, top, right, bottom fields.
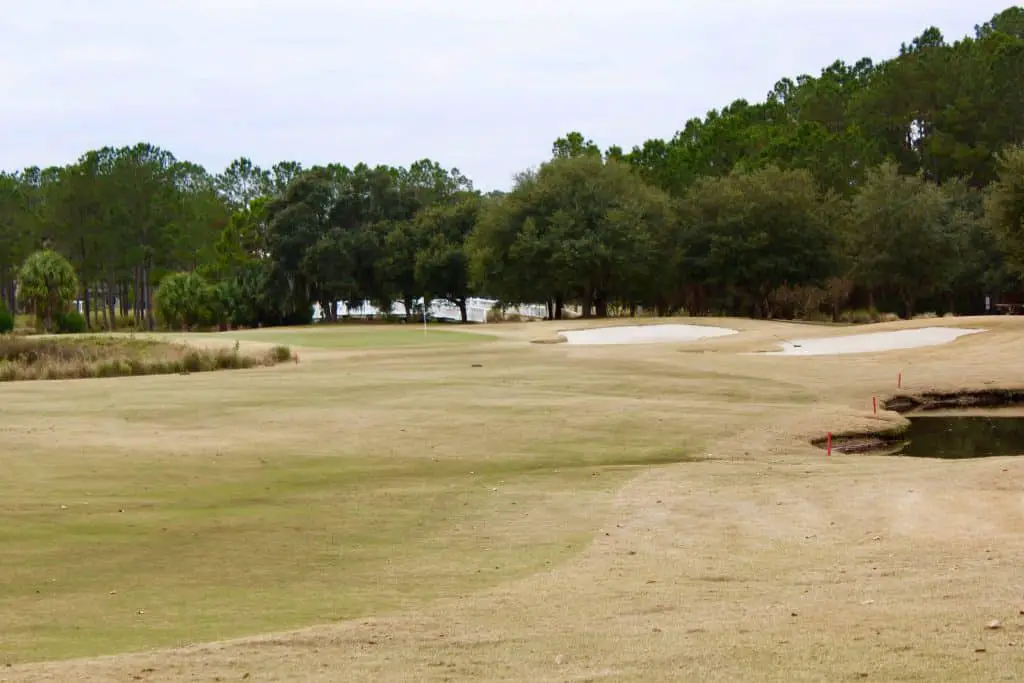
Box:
left=896, top=415, right=1024, bottom=459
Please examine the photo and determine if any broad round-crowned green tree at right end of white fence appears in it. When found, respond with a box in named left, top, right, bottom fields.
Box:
left=468, top=155, right=677, bottom=315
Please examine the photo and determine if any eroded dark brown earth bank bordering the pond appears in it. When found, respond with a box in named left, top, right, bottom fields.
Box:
left=811, top=389, right=1024, bottom=454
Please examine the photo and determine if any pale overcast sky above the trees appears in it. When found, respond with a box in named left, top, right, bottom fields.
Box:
left=0, top=0, right=1013, bottom=189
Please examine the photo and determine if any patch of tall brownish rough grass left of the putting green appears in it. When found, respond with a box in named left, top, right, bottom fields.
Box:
left=0, top=337, right=294, bottom=382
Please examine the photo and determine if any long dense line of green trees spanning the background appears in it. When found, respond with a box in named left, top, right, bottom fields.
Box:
left=0, top=7, right=1024, bottom=328
